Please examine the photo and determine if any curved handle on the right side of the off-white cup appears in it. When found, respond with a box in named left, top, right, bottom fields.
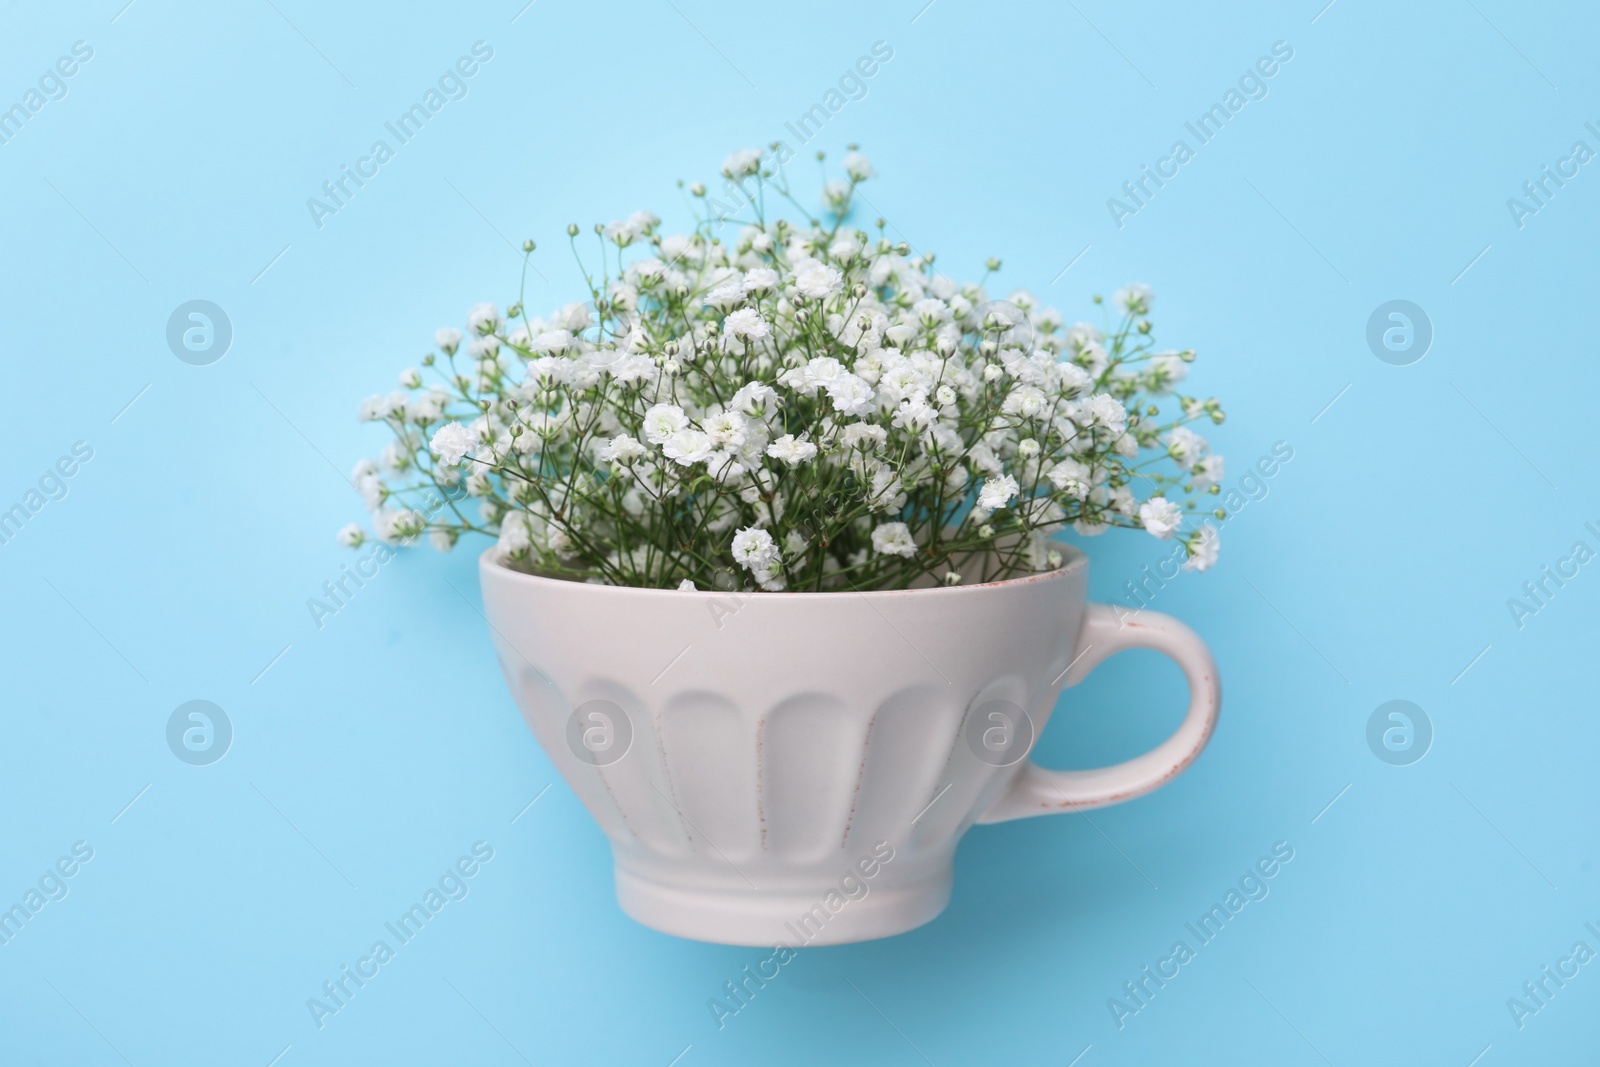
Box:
left=978, top=603, right=1222, bottom=822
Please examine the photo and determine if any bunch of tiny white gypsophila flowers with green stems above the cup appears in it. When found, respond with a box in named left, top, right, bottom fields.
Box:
left=339, top=147, right=1222, bottom=592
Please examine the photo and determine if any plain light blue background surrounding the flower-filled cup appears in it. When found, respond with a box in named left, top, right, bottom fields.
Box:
left=0, top=0, right=1600, bottom=1067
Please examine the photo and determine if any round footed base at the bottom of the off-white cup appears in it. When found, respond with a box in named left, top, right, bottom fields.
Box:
left=616, top=865, right=952, bottom=949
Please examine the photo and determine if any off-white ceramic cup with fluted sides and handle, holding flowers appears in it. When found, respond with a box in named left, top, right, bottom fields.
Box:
left=478, top=549, right=1221, bottom=947
